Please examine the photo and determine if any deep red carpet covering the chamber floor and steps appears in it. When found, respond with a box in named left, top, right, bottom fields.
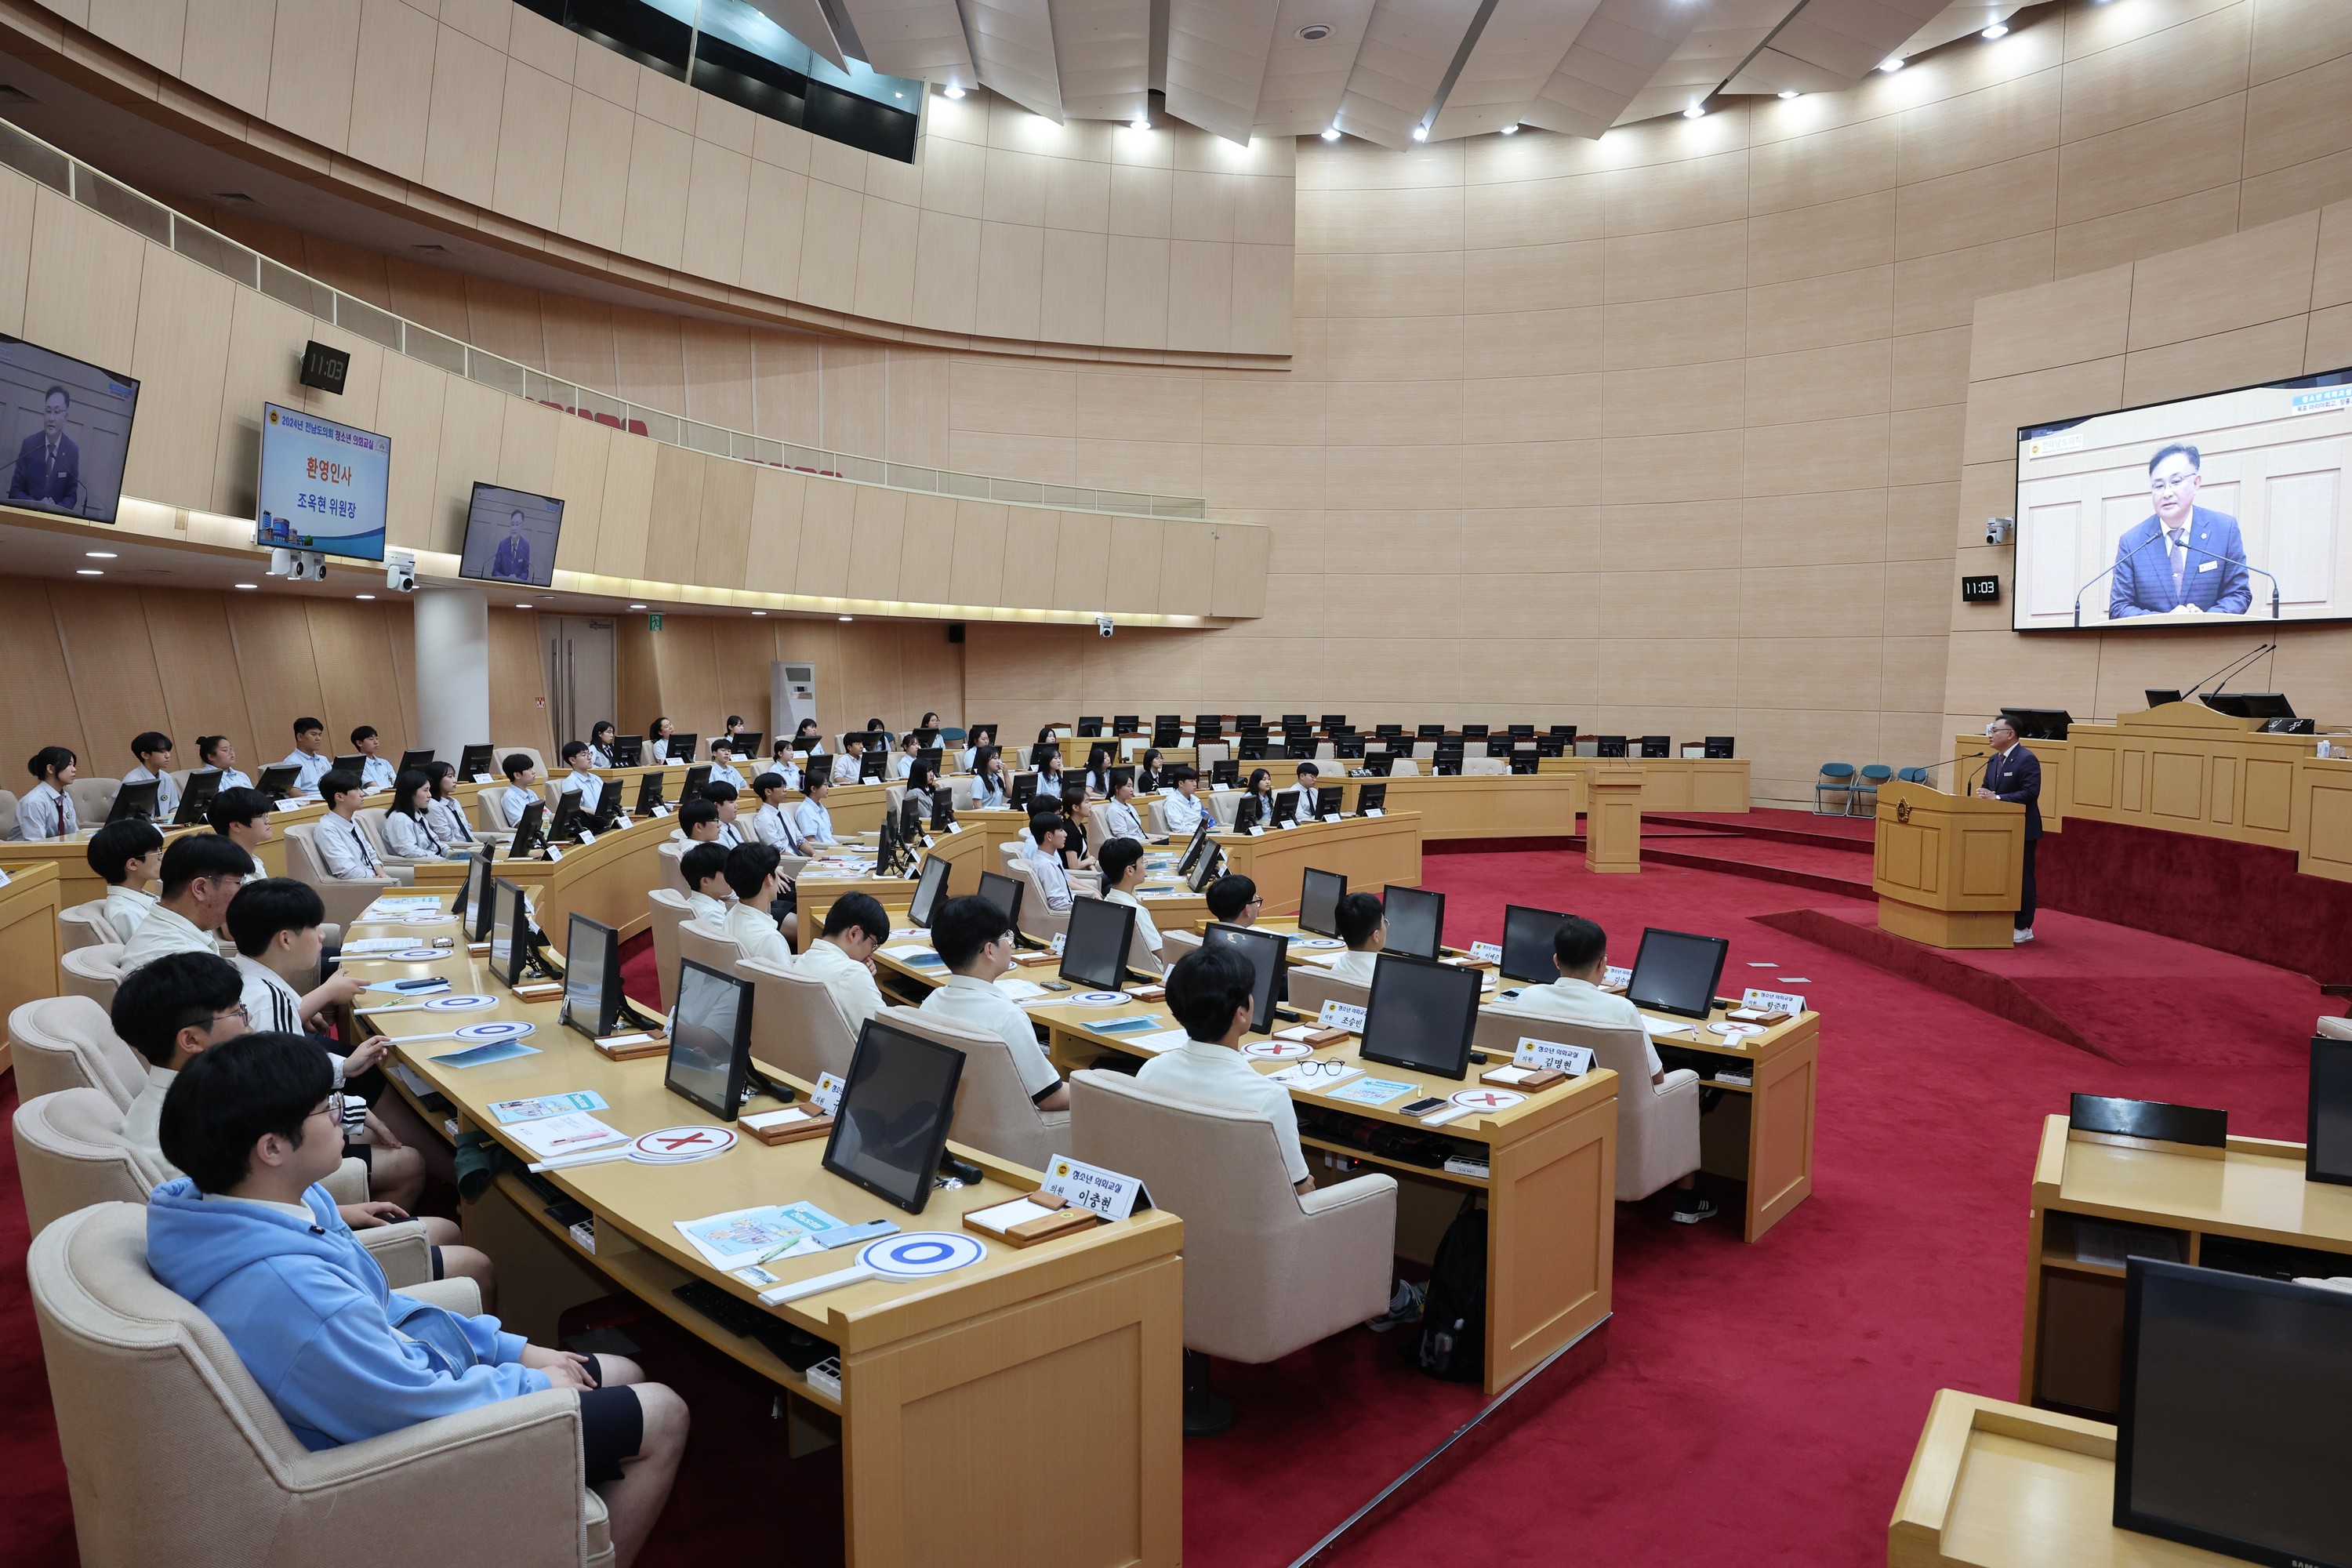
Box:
left=0, top=860, right=2314, bottom=1568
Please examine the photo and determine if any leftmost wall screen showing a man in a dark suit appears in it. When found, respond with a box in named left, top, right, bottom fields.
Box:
left=0, top=334, right=139, bottom=522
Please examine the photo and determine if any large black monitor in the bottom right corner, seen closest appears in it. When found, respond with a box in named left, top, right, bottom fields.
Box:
left=2114, top=1258, right=2352, bottom=1563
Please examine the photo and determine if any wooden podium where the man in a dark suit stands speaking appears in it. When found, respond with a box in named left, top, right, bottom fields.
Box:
left=1870, top=783, right=2025, bottom=947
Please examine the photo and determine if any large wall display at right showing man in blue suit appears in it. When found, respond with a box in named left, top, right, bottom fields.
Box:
left=2011, top=369, right=2352, bottom=633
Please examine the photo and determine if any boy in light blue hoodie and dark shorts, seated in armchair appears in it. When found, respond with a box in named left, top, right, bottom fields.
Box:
left=148, top=1034, right=687, bottom=1568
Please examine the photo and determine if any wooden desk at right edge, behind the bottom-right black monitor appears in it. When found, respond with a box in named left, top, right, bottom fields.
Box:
left=2018, top=1114, right=2352, bottom=1415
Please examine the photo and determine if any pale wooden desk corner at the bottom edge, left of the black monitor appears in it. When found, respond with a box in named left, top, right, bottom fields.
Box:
left=1886, top=1389, right=2237, bottom=1568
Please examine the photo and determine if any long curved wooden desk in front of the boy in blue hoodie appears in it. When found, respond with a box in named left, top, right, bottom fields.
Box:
left=350, top=926, right=1183, bottom=1568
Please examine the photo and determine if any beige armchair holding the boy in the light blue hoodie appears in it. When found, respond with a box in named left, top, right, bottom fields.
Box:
left=26, top=1203, right=614, bottom=1568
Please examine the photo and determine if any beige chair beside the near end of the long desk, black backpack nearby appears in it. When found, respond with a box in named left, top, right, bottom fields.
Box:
left=1070, top=1069, right=1397, bottom=1432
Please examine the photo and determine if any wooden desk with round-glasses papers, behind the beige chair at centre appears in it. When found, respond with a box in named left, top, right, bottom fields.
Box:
left=1030, top=1001, right=1618, bottom=1394
